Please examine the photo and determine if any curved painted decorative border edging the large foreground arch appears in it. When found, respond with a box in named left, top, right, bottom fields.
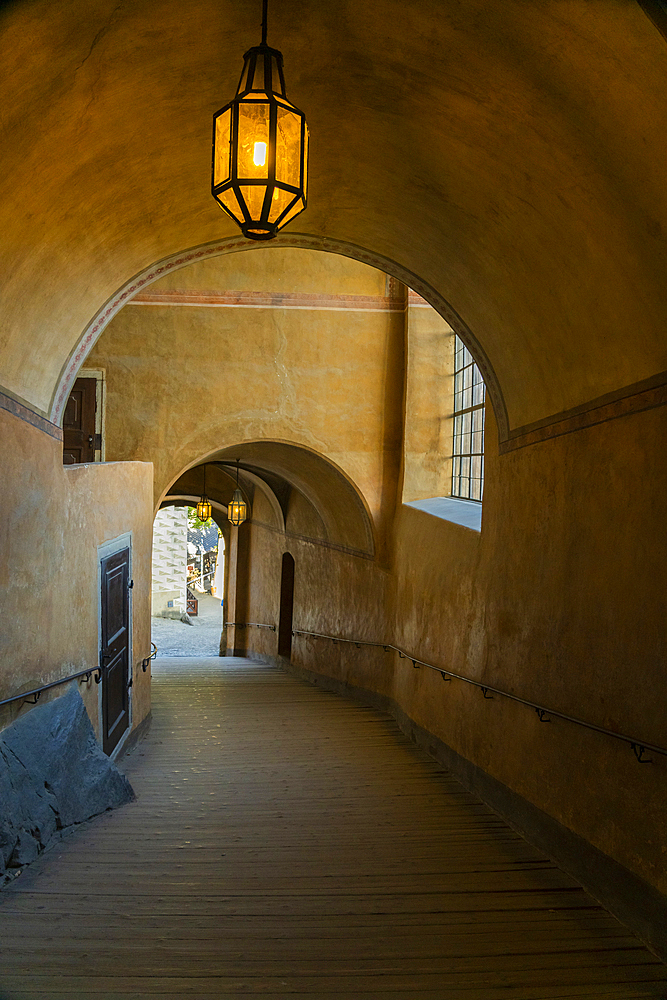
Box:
left=49, top=233, right=509, bottom=441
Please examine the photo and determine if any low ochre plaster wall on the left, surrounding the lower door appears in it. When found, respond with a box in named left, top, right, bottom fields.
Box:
left=0, top=409, right=153, bottom=735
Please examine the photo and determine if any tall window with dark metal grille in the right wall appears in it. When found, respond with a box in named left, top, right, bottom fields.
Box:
left=452, top=337, right=486, bottom=501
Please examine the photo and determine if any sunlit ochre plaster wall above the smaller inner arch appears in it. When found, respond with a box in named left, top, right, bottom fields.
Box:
left=87, top=248, right=405, bottom=548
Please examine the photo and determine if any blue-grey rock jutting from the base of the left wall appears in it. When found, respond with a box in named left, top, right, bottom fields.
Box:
left=0, top=686, right=134, bottom=884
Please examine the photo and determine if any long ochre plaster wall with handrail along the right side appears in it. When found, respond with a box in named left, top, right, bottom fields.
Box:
left=243, top=407, right=667, bottom=892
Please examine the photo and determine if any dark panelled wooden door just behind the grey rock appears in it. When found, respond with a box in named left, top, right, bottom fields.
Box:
left=100, top=549, right=130, bottom=754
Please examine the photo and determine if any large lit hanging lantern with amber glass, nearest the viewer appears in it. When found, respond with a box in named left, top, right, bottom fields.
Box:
left=211, top=0, right=308, bottom=240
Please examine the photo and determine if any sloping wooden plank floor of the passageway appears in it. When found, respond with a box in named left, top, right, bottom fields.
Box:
left=0, top=657, right=667, bottom=1000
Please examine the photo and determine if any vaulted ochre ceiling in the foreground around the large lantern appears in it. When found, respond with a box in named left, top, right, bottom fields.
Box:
left=0, top=0, right=667, bottom=427
